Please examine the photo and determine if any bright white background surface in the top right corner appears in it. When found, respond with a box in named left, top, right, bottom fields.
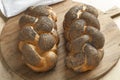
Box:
left=73, top=0, right=120, bottom=12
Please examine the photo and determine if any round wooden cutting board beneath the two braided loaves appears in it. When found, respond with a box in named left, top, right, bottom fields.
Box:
left=0, top=0, right=120, bottom=80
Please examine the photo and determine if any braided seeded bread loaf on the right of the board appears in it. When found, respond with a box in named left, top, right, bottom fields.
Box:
left=63, top=4, right=105, bottom=72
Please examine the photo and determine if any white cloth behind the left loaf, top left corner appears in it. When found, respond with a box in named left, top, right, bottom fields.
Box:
left=0, top=0, right=63, bottom=17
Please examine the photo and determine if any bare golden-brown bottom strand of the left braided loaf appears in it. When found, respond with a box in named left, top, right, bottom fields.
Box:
left=26, top=51, right=57, bottom=72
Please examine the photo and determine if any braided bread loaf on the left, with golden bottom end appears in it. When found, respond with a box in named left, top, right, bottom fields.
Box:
left=19, top=5, right=59, bottom=72
